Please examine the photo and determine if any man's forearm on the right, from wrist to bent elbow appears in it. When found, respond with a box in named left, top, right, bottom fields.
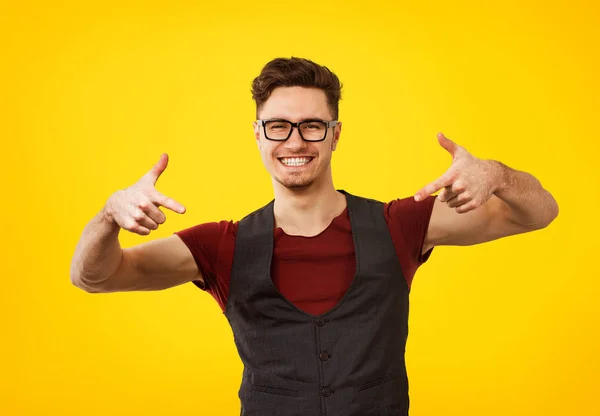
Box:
left=489, top=161, right=558, bottom=229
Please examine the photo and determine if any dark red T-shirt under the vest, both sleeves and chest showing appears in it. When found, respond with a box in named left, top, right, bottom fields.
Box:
left=174, top=196, right=435, bottom=315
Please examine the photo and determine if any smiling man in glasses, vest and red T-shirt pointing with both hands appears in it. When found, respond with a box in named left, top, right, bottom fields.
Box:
left=71, top=58, right=558, bottom=416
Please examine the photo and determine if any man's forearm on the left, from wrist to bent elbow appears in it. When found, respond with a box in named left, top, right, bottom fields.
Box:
left=71, top=209, right=122, bottom=290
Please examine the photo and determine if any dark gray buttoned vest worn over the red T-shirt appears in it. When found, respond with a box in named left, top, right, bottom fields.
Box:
left=225, top=191, right=409, bottom=416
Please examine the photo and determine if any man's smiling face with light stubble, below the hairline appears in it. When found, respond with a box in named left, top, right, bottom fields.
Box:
left=254, top=87, right=341, bottom=189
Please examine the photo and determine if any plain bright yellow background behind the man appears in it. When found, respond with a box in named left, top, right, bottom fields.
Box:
left=0, top=0, right=600, bottom=416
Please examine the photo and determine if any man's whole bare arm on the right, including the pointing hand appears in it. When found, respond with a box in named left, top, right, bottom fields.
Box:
left=416, top=135, right=558, bottom=253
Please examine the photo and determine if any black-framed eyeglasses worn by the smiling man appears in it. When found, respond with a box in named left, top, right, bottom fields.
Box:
left=256, top=119, right=338, bottom=142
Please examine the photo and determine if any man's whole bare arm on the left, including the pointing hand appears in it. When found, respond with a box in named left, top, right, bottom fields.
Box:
left=71, top=156, right=203, bottom=293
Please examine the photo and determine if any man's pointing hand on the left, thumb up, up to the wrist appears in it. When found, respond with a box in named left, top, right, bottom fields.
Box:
left=105, top=153, right=185, bottom=235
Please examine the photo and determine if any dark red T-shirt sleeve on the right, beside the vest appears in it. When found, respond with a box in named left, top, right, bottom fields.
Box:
left=385, top=196, right=436, bottom=287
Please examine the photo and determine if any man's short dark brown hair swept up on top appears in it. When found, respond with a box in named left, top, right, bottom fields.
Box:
left=252, top=56, right=342, bottom=120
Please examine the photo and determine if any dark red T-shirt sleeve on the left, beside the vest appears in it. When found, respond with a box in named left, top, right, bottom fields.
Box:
left=173, top=221, right=237, bottom=309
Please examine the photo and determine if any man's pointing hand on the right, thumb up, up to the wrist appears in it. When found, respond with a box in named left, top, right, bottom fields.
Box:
left=415, top=133, right=499, bottom=214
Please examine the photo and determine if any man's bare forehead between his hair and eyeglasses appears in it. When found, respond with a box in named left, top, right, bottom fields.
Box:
left=260, top=87, right=331, bottom=121
